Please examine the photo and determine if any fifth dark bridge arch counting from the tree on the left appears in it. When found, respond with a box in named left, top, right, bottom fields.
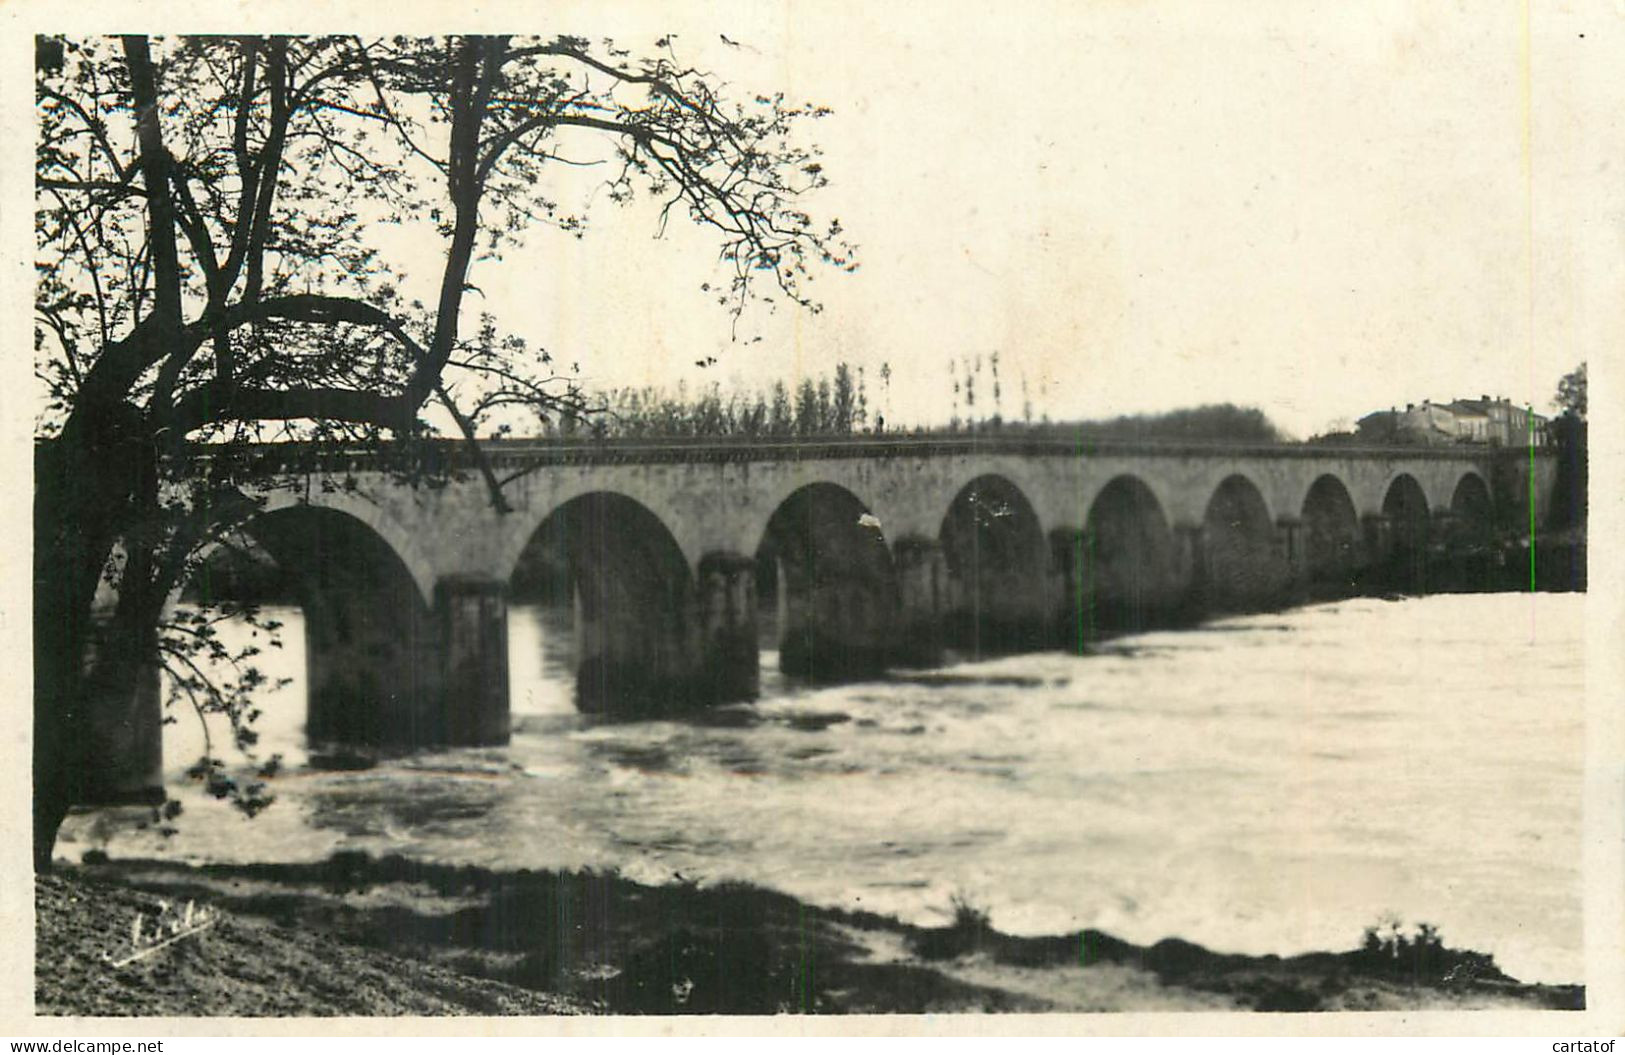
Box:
left=1073, top=473, right=1180, bottom=632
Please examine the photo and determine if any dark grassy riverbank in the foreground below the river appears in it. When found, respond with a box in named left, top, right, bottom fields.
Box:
left=36, top=855, right=1584, bottom=1016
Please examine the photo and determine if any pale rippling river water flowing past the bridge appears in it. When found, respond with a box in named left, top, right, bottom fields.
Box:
left=60, top=593, right=1584, bottom=982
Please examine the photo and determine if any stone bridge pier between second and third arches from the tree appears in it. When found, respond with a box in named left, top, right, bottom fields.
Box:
left=694, top=553, right=761, bottom=704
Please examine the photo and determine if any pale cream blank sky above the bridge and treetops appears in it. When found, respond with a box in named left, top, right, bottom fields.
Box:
left=12, top=0, right=1625, bottom=437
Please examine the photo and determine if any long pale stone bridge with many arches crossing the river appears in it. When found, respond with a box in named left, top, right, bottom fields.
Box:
left=82, top=436, right=1555, bottom=798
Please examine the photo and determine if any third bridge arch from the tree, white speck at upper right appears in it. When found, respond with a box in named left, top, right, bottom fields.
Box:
left=754, top=481, right=899, bottom=679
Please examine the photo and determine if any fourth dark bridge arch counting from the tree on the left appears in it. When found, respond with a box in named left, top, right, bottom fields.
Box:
left=938, top=473, right=1053, bottom=655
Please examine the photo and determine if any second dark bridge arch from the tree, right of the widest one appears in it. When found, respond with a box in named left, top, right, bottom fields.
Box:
left=509, top=491, right=694, bottom=717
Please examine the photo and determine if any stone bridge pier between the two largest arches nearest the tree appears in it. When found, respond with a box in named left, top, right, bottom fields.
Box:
left=434, top=575, right=510, bottom=746
